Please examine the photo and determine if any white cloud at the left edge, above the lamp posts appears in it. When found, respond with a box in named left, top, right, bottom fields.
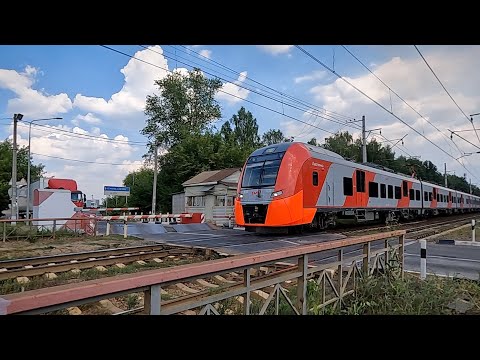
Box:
left=0, top=65, right=72, bottom=119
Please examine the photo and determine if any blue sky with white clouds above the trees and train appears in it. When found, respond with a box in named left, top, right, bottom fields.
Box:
left=0, top=45, right=480, bottom=198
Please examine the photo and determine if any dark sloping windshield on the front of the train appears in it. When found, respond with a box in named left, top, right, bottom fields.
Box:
left=242, top=159, right=282, bottom=187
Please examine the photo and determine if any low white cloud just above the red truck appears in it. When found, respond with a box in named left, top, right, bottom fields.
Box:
left=11, top=125, right=145, bottom=199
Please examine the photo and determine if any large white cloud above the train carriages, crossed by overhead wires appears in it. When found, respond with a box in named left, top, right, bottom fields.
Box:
left=281, top=46, right=480, bottom=183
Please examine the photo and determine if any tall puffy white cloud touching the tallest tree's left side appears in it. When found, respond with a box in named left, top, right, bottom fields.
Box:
left=73, top=46, right=168, bottom=119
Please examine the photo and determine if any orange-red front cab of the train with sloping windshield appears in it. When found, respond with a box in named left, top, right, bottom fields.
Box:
left=235, top=143, right=318, bottom=230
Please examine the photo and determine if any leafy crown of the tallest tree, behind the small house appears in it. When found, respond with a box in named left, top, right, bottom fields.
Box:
left=141, top=68, right=222, bottom=150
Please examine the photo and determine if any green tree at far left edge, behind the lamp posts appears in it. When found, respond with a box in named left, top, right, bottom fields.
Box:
left=0, top=140, right=45, bottom=211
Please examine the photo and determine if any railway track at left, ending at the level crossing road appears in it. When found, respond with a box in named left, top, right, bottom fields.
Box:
left=0, top=245, right=212, bottom=281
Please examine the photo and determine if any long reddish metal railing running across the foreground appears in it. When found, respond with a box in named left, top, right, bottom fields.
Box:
left=0, top=230, right=405, bottom=315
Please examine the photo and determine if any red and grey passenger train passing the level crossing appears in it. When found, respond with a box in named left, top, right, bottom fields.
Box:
left=235, top=142, right=480, bottom=231
